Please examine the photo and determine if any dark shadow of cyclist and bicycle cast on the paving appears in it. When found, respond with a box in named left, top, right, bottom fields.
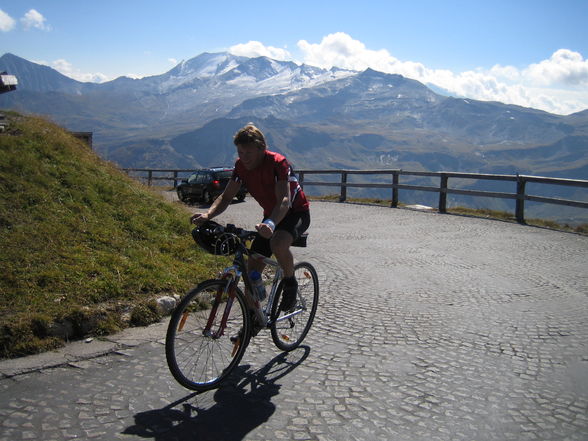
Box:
left=122, top=346, right=310, bottom=441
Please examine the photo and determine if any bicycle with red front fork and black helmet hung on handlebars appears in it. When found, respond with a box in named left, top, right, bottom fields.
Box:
left=165, top=221, right=319, bottom=391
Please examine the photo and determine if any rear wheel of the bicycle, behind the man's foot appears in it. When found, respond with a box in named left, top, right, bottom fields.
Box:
left=270, top=262, right=319, bottom=351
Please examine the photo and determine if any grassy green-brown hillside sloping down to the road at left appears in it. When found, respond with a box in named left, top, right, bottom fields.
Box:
left=0, top=114, right=222, bottom=358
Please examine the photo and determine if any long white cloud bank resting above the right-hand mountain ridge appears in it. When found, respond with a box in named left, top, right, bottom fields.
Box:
left=298, top=32, right=588, bottom=114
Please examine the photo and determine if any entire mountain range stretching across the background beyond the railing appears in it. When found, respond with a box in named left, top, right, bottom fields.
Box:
left=0, top=53, right=588, bottom=222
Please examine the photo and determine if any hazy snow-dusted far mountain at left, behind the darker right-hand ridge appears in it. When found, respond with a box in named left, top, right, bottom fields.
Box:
left=0, top=53, right=356, bottom=140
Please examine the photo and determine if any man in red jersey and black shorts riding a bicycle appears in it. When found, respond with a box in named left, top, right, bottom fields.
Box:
left=190, top=124, right=310, bottom=311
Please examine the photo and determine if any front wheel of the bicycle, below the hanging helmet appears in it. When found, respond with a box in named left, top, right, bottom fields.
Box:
left=165, top=280, right=251, bottom=391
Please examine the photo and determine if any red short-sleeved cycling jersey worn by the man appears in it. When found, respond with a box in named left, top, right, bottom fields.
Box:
left=231, top=150, right=309, bottom=217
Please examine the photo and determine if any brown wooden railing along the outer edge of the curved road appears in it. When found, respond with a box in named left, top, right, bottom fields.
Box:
left=123, top=168, right=588, bottom=223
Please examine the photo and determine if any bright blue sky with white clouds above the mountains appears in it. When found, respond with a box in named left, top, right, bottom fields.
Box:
left=0, top=0, right=588, bottom=114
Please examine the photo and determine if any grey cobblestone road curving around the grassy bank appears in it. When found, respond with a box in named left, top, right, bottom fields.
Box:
left=0, top=199, right=588, bottom=441
